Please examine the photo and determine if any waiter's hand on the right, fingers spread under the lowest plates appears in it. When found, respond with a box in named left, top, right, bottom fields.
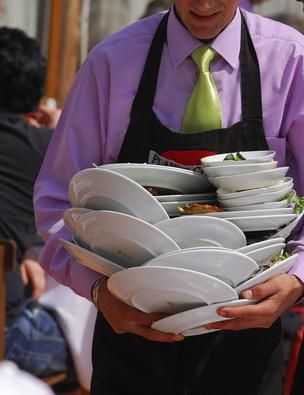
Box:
left=205, top=274, right=304, bottom=330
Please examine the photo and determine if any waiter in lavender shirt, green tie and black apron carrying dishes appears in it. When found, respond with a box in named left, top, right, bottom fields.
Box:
left=35, top=0, right=304, bottom=395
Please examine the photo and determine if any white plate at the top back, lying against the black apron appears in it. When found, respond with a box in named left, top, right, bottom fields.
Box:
left=99, top=163, right=214, bottom=193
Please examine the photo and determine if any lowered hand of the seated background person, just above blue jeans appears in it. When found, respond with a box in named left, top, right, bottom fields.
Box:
left=20, top=259, right=45, bottom=299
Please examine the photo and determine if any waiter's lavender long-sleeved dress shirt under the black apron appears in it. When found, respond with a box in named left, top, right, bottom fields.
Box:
left=34, top=6, right=304, bottom=299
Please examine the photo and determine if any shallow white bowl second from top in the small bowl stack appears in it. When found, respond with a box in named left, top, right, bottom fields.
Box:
left=203, top=160, right=278, bottom=177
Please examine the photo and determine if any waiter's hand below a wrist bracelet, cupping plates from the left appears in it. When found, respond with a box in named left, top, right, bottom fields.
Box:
left=98, top=280, right=184, bottom=342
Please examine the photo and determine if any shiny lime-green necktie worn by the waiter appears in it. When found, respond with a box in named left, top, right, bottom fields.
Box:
left=182, top=46, right=222, bottom=133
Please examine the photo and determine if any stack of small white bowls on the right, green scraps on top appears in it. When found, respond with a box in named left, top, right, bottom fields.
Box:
left=201, top=151, right=296, bottom=232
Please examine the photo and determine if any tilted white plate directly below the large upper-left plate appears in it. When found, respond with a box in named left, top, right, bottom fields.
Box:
left=75, top=210, right=179, bottom=267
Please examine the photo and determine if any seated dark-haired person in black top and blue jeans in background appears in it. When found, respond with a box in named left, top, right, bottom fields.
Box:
left=0, top=27, right=74, bottom=377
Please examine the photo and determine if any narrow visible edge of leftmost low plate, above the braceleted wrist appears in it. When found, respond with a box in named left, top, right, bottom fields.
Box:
left=60, top=239, right=124, bottom=277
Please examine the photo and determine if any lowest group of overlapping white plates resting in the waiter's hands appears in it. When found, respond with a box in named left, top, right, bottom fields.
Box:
left=108, top=244, right=297, bottom=336
